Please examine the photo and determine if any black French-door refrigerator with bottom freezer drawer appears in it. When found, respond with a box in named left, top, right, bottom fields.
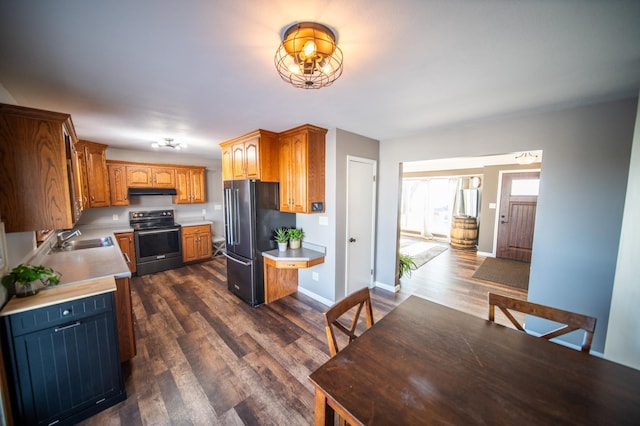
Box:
left=224, top=180, right=296, bottom=306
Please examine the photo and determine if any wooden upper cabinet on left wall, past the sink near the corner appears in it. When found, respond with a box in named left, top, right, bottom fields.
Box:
left=76, top=140, right=111, bottom=207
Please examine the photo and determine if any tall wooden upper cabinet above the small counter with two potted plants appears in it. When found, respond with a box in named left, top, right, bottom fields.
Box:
left=279, top=124, right=327, bottom=213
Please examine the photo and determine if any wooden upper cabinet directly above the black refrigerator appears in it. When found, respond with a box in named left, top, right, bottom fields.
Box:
left=220, top=129, right=279, bottom=182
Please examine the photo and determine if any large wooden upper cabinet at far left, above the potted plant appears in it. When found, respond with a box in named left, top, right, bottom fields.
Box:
left=0, top=104, right=81, bottom=232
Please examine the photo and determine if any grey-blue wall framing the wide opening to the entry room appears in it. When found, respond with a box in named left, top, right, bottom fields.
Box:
left=376, top=98, right=637, bottom=351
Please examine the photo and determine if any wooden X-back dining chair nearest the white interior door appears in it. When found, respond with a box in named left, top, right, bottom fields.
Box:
left=324, top=287, right=373, bottom=356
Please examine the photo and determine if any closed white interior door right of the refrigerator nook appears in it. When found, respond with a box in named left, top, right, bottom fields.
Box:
left=345, top=157, right=376, bottom=296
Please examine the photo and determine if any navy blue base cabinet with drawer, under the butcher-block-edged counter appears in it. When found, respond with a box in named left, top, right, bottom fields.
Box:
left=3, top=292, right=126, bottom=425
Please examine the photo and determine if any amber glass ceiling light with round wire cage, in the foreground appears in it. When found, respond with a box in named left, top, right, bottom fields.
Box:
left=274, top=22, right=342, bottom=89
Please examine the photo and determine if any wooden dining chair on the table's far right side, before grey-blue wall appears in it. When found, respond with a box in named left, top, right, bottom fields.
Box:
left=489, top=292, right=596, bottom=353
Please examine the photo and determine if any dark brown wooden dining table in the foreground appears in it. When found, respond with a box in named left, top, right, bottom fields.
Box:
left=309, top=296, right=640, bottom=426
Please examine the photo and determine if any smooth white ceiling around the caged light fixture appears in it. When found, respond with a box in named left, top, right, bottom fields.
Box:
left=0, top=0, right=640, bottom=158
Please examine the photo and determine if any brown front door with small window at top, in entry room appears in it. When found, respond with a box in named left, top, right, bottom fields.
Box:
left=496, top=172, right=540, bottom=262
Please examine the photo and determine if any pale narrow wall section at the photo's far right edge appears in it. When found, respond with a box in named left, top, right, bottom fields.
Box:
left=604, top=93, right=640, bottom=369
